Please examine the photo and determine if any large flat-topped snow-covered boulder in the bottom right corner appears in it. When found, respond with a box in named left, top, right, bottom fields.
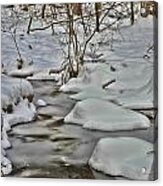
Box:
left=89, top=137, right=154, bottom=180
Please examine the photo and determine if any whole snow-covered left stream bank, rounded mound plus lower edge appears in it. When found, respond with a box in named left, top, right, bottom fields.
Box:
left=1, top=75, right=36, bottom=175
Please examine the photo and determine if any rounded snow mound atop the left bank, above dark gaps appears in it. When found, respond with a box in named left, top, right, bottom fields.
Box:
left=1, top=75, right=34, bottom=109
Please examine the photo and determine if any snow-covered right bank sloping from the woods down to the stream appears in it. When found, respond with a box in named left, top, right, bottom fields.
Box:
left=60, top=16, right=155, bottom=109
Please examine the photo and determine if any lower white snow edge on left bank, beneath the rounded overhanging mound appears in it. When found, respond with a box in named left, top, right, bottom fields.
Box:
left=1, top=98, right=36, bottom=175
